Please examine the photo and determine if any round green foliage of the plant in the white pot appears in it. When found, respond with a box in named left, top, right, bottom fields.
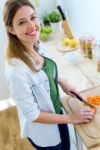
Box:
left=48, top=11, right=61, bottom=23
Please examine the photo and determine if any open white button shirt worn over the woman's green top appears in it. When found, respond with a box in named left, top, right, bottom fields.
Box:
left=5, top=45, right=61, bottom=147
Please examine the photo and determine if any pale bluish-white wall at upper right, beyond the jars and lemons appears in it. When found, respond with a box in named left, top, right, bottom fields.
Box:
left=62, top=0, right=100, bottom=39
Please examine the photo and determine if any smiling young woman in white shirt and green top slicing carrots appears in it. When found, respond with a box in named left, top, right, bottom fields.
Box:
left=3, top=0, right=94, bottom=150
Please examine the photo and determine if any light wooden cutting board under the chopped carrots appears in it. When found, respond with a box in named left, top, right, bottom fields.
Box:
left=62, top=86, right=100, bottom=150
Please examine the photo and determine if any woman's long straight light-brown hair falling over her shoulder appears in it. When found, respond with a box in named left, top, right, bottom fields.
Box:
left=3, top=0, right=36, bottom=71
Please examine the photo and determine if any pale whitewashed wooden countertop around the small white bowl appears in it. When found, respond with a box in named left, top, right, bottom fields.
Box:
left=43, top=35, right=100, bottom=95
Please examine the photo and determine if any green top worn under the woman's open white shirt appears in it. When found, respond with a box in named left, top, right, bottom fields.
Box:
left=42, top=58, right=61, bottom=113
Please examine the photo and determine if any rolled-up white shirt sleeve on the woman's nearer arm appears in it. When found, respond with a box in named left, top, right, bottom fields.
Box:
left=8, top=69, right=40, bottom=121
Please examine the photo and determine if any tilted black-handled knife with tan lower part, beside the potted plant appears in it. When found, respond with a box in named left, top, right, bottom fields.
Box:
left=57, top=5, right=74, bottom=39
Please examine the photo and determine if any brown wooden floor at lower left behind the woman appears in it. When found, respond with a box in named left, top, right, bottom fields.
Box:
left=0, top=106, right=35, bottom=150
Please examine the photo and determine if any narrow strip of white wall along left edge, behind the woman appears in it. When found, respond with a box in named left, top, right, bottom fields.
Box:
left=0, top=0, right=9, bottom=99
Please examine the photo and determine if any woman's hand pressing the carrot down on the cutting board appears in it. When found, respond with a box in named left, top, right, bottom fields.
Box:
left=68, top=109, right=94, bottom=124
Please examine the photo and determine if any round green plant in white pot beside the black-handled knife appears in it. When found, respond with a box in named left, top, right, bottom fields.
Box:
left=48, top=10, right=62, bottom=32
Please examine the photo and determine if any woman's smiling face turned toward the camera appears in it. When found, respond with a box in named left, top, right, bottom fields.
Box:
left=9, top=6, right=40, bottom=45
